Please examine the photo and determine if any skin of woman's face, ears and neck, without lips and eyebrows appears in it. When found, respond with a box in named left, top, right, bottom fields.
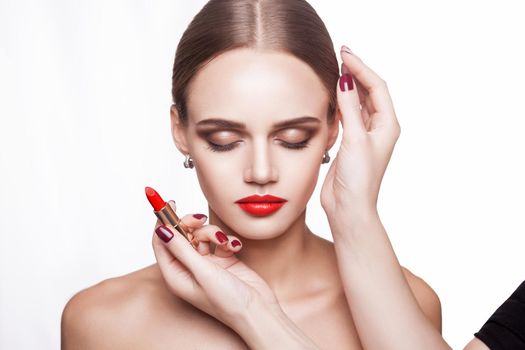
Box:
left=171, top=46, right=338, bottom=301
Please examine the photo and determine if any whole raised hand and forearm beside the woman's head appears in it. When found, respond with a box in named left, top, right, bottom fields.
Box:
left=314, top=46, right=485, bottom=350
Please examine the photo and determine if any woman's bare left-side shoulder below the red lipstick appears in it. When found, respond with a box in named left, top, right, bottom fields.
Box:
left=61, top=267, right=172, bottom=349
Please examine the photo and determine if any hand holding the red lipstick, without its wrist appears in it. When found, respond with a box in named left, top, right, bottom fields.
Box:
left=152, top=201, right=279, bottom=328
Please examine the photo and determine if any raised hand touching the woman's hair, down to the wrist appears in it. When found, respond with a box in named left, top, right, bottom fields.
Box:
left=321, top=48, right=401, bottom=215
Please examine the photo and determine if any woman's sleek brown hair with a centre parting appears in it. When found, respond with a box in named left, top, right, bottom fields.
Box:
left=171, top=0, right=339, bottom=126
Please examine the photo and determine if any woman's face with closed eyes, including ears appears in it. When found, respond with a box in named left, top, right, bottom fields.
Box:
left=172, top=49, right=338, bottom=239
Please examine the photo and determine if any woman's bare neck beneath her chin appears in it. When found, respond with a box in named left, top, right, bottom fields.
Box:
left=209, top=208, right=315, bottom=300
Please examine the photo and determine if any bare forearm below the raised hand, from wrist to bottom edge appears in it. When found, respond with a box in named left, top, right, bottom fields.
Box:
left=330, top=212, right=451, bottom=350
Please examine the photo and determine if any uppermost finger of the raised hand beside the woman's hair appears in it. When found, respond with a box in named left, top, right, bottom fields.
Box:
left=341, top=47, right=393, bottom=121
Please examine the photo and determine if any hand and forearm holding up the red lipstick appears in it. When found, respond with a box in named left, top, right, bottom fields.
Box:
left=153, top=221, right=319, bottom=349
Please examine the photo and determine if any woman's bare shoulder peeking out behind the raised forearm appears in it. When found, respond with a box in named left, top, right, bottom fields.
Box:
left=401, top=266, right=442, bottom=333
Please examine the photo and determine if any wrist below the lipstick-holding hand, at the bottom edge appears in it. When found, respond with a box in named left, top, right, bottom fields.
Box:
left=234, top=301, right=319, bottom=350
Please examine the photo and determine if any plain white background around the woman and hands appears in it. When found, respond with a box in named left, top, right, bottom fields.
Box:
left=0, top=0, right=525, bottom=349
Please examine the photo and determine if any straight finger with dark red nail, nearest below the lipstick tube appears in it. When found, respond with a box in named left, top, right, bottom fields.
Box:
left=154, top=225, right=217, bottom=285
